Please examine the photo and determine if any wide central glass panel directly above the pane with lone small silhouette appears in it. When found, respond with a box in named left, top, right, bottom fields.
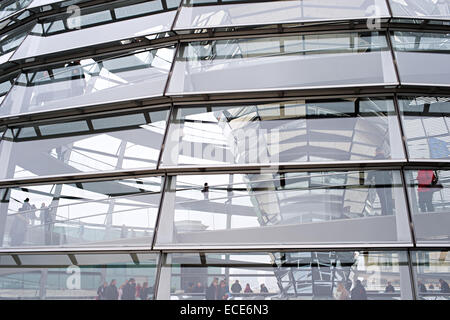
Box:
left=163, top=98, right=404, bottom=166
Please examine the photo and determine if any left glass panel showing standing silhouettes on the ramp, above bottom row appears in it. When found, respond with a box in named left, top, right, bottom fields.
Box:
left=0, top=177, right=161, bottom=247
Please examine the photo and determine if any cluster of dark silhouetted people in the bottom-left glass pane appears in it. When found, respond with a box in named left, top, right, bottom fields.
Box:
left=97, top=278, right=154, bottom=300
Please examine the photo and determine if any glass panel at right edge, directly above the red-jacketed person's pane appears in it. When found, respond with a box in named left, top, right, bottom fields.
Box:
left=398, top=96, right=450, bottom=160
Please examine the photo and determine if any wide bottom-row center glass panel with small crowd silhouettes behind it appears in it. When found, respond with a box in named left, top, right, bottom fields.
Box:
left=158, top=251, right=412, bottom=300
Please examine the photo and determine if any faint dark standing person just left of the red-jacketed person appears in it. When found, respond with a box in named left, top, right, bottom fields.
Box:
left=367, top=147, right=393, bottom=216
